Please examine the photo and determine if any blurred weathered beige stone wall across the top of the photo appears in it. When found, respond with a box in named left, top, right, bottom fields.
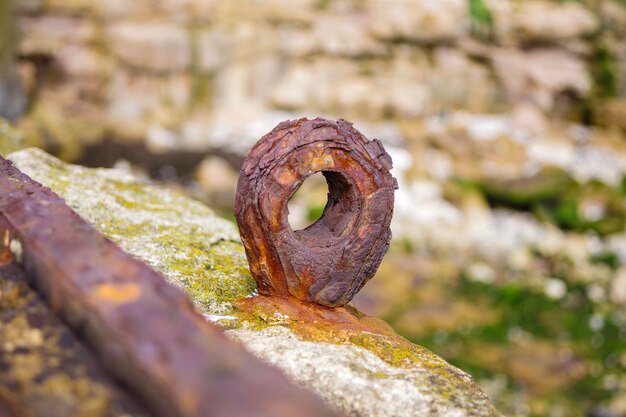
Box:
left=8, top=0, right=626, bottom=159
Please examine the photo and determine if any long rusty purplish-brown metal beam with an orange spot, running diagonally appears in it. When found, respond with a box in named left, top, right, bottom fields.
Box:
left=0, top=158, right=335, bottom=417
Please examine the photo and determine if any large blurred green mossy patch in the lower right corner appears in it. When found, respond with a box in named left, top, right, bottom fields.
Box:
left=412, top=271, right=626, bottom=416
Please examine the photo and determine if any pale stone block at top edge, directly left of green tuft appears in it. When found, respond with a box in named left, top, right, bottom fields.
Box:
left=366, top=0, right=469, bottom=42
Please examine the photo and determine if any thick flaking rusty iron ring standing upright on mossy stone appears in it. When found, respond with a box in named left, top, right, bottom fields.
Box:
left=235, top=118, right=397, bottom=307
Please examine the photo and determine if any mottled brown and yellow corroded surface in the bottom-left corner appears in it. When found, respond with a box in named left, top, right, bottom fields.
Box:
left=0, top=262, right=151, bottom=417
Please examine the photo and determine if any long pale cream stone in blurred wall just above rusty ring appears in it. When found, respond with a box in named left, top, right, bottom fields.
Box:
left=270, top=47, right=500, bottom=120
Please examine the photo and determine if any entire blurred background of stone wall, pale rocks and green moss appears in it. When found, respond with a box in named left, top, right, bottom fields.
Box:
left=0, top=0, right=626, bottom=417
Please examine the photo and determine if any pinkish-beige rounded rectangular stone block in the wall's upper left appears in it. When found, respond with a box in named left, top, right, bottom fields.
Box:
left=107, top=22, right=191, bottom=72
